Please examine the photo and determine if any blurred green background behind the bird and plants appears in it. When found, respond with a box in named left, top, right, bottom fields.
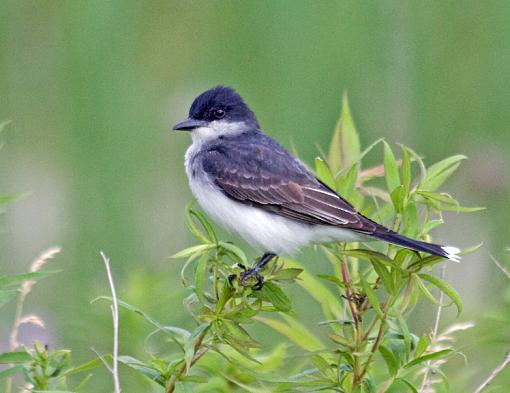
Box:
left=0, top=0, right=510, bottom=392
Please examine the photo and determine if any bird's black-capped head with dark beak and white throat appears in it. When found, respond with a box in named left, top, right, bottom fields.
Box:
left=173, top=86, right=259, bottom=140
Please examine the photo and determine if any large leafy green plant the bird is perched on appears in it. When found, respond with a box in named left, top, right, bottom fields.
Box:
left=101, top=93, right=480, bottom=392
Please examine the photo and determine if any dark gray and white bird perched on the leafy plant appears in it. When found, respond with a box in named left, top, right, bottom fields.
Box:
left=173, top=86, right=460, bottom=288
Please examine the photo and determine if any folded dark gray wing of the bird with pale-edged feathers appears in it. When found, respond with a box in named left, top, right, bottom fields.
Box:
left=200, top=137, right=379, bottom=234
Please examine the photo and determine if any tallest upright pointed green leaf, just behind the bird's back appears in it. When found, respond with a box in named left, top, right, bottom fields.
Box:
left=328, top=93, right=360, bottom=174
